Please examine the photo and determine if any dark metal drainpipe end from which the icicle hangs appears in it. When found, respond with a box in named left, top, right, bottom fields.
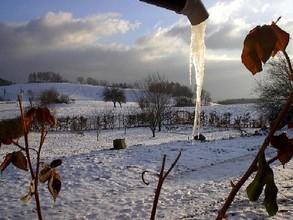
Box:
left=140, top=0, right=209, bottom=25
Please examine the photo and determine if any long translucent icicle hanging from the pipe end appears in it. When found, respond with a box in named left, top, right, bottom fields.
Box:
left=189, top=21, right=206, bottom=136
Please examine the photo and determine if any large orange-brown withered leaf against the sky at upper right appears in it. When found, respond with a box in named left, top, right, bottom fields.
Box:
left=241, top=22, right=290, bottom=75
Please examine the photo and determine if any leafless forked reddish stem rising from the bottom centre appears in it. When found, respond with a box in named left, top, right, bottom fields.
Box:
left=150, top=152, right=181, bottom=220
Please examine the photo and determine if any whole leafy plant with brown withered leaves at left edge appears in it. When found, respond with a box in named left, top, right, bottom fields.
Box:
left=0, top=96, right=62, bottom=219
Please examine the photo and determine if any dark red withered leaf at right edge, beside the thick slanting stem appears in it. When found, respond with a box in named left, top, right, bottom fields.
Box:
left=271, top=133, right=293, bottom=165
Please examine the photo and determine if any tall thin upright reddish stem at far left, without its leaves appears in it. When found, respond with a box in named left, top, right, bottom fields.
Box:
left=18, top=96, right=43, bottom=220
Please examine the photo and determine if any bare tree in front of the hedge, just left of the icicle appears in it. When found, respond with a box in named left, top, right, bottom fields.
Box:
left=138, top=74, right=171, bottom=137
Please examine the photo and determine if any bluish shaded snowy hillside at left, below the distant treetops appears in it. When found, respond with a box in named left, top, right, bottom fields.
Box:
left=0, top=83, right=140, bottom=102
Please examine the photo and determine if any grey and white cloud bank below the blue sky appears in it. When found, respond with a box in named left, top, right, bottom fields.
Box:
left=0, top=5, right=293, bottom=100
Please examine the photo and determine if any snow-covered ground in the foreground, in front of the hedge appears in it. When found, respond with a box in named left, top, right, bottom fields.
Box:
left=0, top=128, right=293, bottom=219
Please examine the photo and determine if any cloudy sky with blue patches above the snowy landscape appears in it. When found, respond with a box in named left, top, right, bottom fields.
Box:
left=0, top=0, right=293, bottom=100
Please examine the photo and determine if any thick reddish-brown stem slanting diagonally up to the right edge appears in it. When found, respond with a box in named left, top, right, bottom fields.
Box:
left=216, top=92, right=293, bottom=220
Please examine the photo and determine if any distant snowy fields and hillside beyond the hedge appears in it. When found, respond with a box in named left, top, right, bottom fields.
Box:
left=0, top=83, right=259, bottom=120
